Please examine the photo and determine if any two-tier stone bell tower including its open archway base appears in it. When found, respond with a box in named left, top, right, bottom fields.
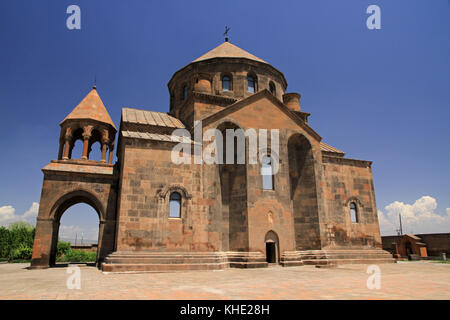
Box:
left=31, top=86, right=118, bottom=268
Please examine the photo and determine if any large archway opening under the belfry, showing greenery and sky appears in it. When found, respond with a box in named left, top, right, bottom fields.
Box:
left=55, top=203, right=100, bottom=265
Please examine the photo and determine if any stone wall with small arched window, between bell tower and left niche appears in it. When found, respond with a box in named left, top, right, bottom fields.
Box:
left=117, top=139, right=221, bottom=252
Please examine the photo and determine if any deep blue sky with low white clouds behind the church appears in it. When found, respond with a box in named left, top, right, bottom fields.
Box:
left=0, top=0, right=450, bottom=240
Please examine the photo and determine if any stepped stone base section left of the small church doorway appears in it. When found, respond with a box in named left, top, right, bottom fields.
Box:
left=102, top=251, right=267, bottom=272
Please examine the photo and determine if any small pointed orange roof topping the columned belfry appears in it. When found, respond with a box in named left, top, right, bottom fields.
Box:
left=61, top=86, right=117, bottom=130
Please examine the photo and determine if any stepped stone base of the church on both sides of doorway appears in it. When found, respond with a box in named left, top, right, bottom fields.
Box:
left=101, top=248, right=395, bottom=272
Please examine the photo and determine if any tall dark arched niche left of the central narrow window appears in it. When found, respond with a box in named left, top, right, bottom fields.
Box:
left=217, top=122, right=249, bottom=251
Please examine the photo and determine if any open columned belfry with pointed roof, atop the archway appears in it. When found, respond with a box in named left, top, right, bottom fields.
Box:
left=58, top=86, right=117, bottom=164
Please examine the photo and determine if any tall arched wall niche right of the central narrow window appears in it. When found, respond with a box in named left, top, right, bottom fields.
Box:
left=288, top=134, right=321, bottom=250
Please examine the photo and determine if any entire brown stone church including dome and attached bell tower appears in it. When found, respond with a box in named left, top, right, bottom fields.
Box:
left=31, top=39, right=394, bottom=272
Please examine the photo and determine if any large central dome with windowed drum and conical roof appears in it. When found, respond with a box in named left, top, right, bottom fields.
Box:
left=168, top=41, right=287, bottom=114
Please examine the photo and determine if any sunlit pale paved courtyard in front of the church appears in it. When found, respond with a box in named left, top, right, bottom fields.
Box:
left=0, top=262, right=450, bottom=300
